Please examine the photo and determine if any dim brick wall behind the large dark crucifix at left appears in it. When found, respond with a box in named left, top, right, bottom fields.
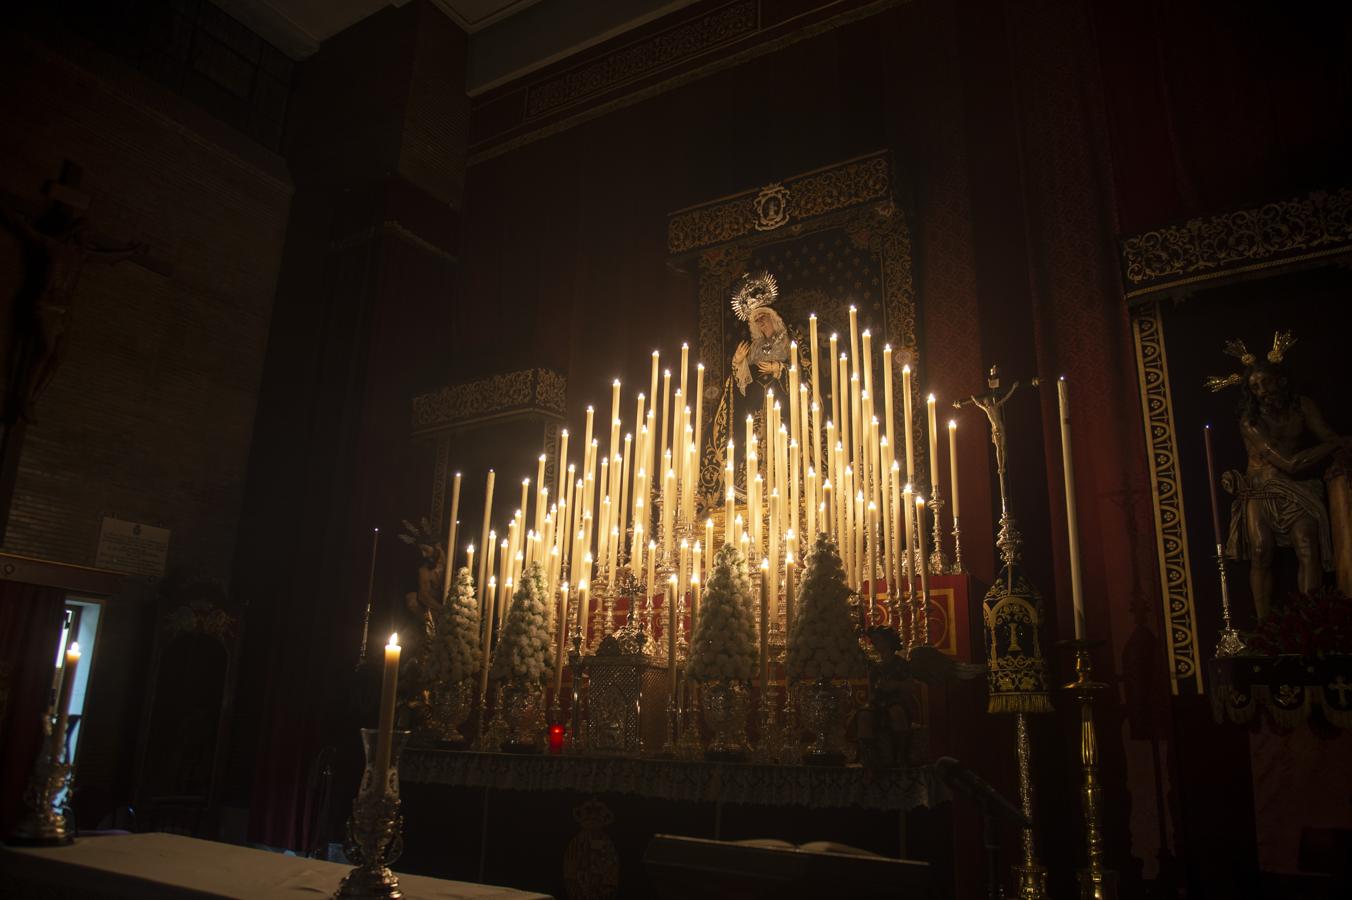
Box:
left=0, top=24, right=292, bottom=810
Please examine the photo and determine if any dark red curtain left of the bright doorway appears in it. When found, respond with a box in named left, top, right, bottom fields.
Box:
left=0, top=581, right=65, bottom=834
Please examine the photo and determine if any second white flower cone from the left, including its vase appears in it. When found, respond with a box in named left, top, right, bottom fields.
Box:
left=489, top=562, right=554, bottom=753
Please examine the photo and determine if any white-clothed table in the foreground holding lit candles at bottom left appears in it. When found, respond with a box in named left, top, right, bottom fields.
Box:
left=0, top=834, right=550, bottom=900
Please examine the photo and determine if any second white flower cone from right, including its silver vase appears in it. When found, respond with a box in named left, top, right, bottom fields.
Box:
left=687, top=545, right=757, bottom=759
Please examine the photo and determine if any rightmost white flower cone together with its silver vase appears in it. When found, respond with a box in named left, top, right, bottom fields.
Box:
left=786, top=535, right=865, bottom=765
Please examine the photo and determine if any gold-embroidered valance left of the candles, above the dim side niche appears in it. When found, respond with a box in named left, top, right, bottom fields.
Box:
left=412, top=369, right=568, bottom=434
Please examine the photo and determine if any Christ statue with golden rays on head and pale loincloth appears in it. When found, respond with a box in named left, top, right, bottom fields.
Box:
left=1206, top=331, right=1352, bottom=619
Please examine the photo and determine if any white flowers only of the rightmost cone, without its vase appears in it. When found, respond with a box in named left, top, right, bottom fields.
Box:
left=786, top=534, right=864, bottom=681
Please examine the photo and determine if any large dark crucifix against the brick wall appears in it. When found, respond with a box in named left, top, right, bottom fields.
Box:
left=0, top=159, right=146, bottom=531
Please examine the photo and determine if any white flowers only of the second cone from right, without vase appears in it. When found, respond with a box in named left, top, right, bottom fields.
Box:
left=688, top=543, right=757, bottom=681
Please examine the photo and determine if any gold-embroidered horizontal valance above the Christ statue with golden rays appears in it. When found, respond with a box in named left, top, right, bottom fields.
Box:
left=1122, top=188, right=1352, bottom=300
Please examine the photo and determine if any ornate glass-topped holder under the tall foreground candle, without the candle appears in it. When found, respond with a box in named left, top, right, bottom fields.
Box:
left=334, top=728, right=410, bottom=900
